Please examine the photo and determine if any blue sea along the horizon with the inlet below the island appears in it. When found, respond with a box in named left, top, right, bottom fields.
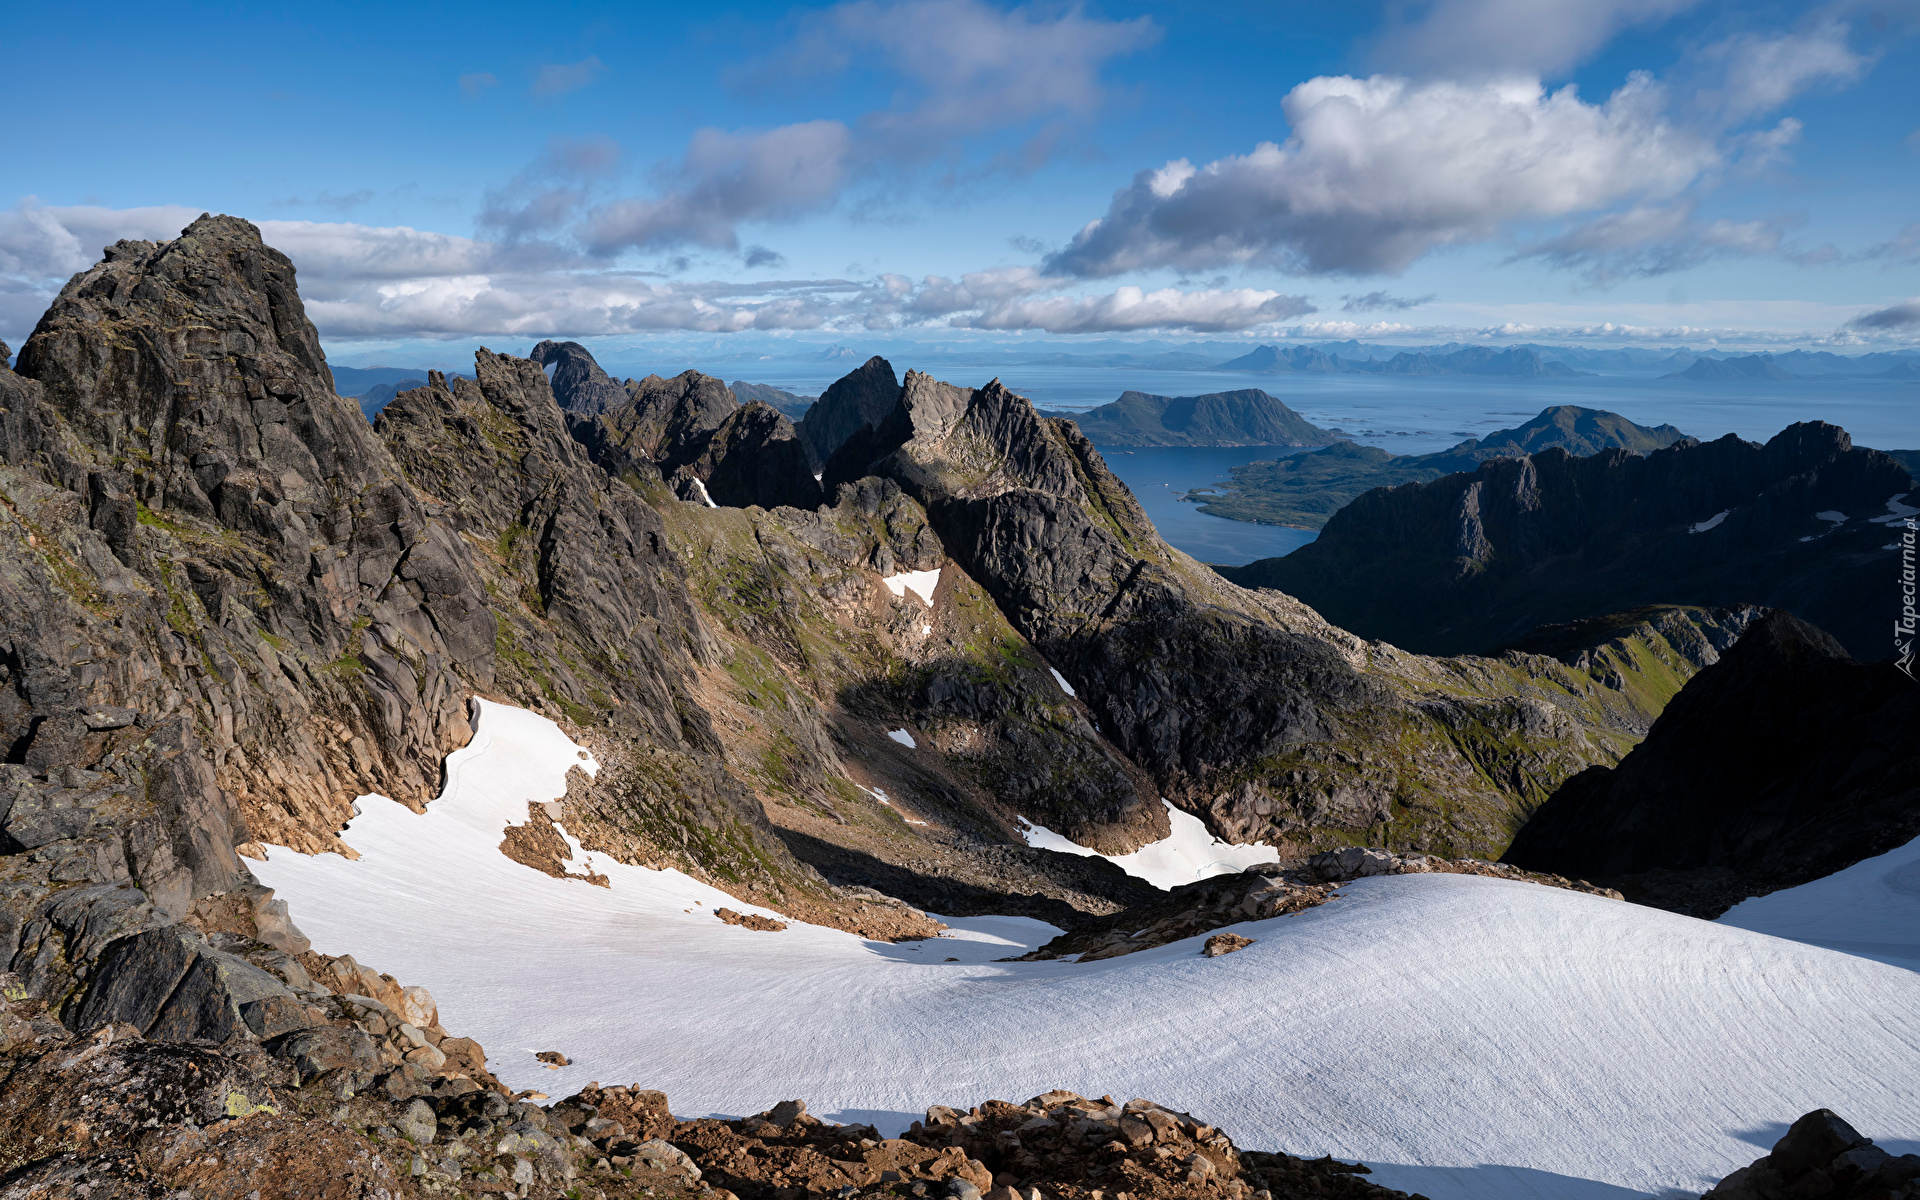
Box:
left=633, top=361, right=1920, bottom=564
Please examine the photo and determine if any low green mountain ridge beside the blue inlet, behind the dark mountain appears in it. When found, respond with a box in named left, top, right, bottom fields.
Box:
left=1188, top=405, right=1686, bottom=530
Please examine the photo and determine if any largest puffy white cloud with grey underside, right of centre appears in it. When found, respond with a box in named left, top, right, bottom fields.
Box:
left=1046, top=75, right=1720, bottom=276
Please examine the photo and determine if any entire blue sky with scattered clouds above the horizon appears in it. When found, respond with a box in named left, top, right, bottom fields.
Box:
left=0, top=0, right=1920, bottom=365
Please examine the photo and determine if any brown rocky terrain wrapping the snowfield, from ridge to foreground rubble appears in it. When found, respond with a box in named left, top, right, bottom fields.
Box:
left=0, top=217, right=1881, bottom=1200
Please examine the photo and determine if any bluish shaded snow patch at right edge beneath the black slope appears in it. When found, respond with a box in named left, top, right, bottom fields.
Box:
left=1720, top=837, right=1920, bottom=972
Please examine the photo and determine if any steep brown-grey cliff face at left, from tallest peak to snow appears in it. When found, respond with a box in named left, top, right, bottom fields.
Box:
left=10, top=217, right=493, bottom=849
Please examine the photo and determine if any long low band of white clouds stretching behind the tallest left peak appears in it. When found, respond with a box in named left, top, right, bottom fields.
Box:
left=0, top=202, right=1313, bottom=340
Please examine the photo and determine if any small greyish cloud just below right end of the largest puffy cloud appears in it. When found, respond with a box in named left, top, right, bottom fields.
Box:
left=1509, top=202, right=1786, bottom=286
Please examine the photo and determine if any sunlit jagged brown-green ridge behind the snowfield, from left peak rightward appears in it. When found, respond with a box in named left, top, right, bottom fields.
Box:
left=0, top=217, right=1758, bottom=1044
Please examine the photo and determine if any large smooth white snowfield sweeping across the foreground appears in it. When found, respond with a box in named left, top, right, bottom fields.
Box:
left=255, top=701, right=1920, bottom=1200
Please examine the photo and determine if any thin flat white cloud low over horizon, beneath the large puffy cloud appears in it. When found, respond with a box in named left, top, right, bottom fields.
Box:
left=950, top=288, right=1313, bottom=334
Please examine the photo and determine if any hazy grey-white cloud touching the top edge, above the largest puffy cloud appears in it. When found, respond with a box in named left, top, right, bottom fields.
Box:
left=1379, top=0, right=1699, bottom=77
